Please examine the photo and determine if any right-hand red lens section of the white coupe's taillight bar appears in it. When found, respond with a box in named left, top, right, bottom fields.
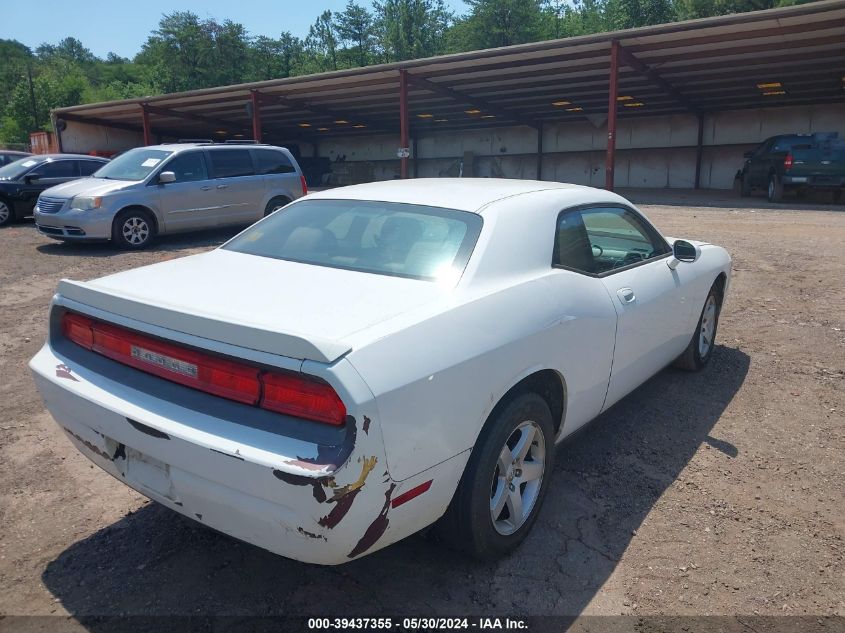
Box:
left=260, top=373, right=346, bottom=426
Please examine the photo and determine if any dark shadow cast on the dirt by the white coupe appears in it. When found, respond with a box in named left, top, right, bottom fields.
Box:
left=42, top=346, right=749, bottom=632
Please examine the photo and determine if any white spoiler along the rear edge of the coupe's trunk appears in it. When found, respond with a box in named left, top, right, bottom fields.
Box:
left=57, top=279, right=352, bottom=363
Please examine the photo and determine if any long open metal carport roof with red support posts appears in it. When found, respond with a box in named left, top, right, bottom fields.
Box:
left=53, top=0, right=845, bottom=189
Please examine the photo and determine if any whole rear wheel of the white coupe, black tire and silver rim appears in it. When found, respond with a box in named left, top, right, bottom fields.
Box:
left=434, top=393, right=555, bottom=560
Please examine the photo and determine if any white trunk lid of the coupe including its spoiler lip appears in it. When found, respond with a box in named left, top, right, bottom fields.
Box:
left=59, top=250, right=445, bottom=363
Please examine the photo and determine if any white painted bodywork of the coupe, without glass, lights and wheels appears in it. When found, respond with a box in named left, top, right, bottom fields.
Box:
left=30, top=179, right=730, bottom=564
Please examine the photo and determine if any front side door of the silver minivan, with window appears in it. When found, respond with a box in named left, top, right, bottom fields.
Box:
left=150, top=150, right=220, bottom=232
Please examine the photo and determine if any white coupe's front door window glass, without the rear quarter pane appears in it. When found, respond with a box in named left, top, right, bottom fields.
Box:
left=581, top=207, right=669, bottom=274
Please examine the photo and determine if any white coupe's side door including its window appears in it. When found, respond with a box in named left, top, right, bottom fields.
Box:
left=580, top=205, right=692, bottom=408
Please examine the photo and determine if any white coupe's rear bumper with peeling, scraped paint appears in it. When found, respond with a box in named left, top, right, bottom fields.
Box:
left=30, top=344, right=406, bottom=565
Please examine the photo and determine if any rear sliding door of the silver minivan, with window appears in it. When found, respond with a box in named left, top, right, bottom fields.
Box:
left=208, top=147, right=264, bottom=226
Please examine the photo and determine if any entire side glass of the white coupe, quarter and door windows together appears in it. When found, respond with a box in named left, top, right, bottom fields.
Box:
left=553, top=207, right=669, bottom=275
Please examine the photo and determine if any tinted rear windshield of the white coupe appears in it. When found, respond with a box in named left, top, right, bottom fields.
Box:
left=222, top=200, right=482, bottom=280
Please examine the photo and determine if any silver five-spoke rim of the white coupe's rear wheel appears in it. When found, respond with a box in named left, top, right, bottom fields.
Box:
left=490, top=421, right=546, bottom=536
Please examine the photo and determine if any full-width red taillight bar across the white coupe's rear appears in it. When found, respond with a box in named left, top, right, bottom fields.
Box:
left=62, top=312, right=346, bottom=426
